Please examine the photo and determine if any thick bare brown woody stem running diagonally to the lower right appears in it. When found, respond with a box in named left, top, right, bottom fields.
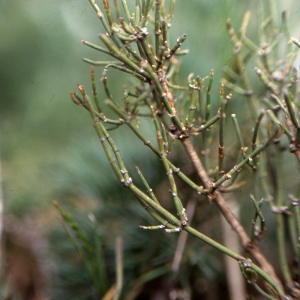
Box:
left=180, top=137, right=282, bottom=287
